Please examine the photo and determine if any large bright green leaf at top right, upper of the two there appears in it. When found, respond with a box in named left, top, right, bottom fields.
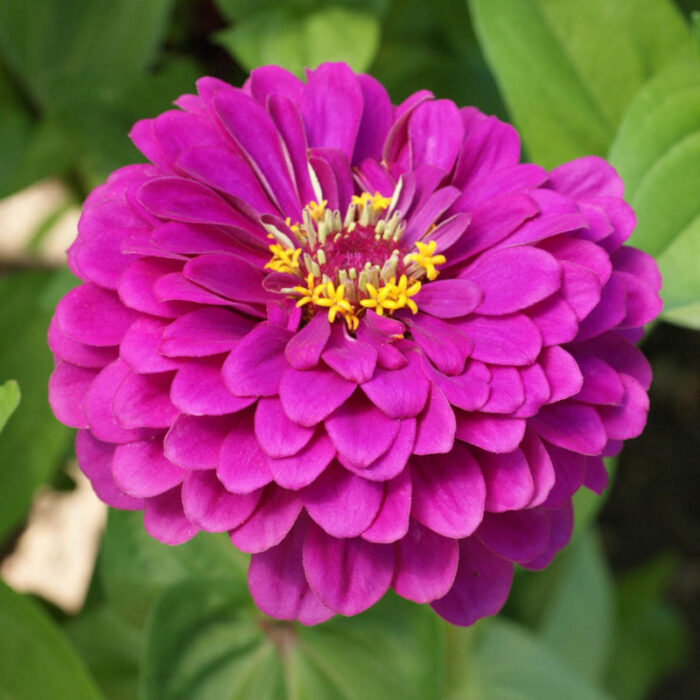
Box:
left=470, top=0, right=693, bottom=167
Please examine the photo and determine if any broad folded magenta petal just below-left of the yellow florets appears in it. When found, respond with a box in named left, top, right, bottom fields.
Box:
left=222, top=323, right=292, bottom=396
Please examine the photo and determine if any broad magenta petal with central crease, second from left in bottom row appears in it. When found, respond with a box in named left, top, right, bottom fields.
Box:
left=304, top=525, right=394, bottom=615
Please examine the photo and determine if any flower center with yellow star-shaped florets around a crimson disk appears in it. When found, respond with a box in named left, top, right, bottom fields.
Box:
left=265, top=192, right=445, bottom=330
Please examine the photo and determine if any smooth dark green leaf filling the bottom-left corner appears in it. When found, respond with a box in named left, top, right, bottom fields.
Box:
left=0, top=581, right=101, bottom=700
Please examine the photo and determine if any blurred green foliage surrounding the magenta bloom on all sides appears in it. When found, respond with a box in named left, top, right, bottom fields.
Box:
left=0, top=0, right=700, bottom=700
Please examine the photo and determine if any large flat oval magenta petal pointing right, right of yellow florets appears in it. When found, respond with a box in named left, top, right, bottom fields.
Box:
left=460, top=246, right=561, bottom=316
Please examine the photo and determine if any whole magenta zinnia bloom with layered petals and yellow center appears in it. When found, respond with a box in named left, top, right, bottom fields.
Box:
left=49, top=64, right=661, bottom=625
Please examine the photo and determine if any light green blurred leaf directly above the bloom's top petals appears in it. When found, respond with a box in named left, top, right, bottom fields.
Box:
left=217, top=7, right=379, bottom=76
